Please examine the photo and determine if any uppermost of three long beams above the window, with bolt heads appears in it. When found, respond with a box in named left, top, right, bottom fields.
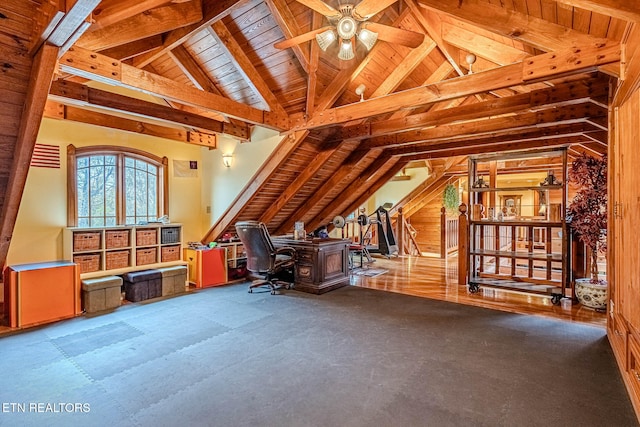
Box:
left=60, top=47, right=289, bottom=131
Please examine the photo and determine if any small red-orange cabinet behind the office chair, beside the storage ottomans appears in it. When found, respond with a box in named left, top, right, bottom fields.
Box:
left=184, top=248, right=227, bottom=288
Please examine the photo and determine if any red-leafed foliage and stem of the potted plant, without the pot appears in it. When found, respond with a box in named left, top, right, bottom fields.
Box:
left=567, top=154, right=607, bottom=283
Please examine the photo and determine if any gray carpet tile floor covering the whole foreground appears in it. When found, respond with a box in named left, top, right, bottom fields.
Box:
left=0, top=284, right=638, bottom=427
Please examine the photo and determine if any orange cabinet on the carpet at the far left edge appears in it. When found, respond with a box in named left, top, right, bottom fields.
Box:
left=4, top=261, right=82, bottom=328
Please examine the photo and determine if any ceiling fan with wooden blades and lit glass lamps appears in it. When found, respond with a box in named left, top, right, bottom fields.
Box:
left=274, top=0, right=424, bottom=60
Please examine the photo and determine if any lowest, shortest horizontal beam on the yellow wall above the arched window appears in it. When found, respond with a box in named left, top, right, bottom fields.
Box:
left=44, top=100, right=217, bottom=148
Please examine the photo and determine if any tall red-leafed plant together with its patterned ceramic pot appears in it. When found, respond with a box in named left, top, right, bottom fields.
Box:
left=567, top=154, right=607, bottom=310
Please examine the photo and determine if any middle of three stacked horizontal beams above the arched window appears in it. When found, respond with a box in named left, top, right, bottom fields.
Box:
left=49, top=80, right=249, bottom=140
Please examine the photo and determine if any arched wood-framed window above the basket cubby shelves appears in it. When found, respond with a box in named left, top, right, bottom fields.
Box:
left=67, top=145, right=168, bottom=227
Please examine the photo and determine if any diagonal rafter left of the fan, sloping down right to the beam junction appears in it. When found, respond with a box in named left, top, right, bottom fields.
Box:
left=207, top=21, right=287, bottom=116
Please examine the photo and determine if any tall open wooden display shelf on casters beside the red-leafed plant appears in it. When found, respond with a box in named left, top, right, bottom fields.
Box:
left=468, top=149, right=571, bottom=304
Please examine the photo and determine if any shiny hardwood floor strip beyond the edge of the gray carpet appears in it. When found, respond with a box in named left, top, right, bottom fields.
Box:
left=351, top=256, right=607, bottom=328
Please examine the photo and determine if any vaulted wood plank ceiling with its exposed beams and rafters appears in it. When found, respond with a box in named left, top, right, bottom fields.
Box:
left=0, top=0, right=640, bottom=268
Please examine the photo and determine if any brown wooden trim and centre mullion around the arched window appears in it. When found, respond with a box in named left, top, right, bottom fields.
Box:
left=67, top=144, right=169, bottom=227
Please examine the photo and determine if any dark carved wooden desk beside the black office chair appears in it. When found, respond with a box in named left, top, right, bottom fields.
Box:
left=272, top=237, right=351, bottom=294
